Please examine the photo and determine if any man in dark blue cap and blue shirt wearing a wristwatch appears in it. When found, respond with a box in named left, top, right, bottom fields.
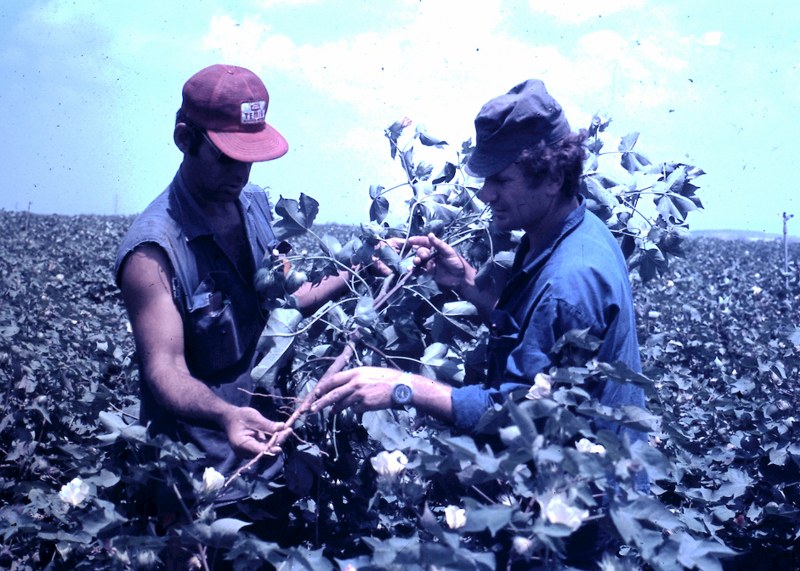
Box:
left=315, top=80, right=648, bottom=566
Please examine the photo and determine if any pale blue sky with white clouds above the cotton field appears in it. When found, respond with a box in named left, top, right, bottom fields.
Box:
left=0, top=0, right=800, bottom=234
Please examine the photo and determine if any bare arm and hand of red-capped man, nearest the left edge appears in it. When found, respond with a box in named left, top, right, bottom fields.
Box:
left=120, top=244, right=282, bottom=454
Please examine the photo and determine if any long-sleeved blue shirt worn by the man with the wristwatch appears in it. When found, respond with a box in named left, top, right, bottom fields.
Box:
left=452, top=202, right=645, bottom=444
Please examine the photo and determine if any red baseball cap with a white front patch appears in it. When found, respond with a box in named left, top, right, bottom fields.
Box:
left=181, top=64, right=289, bottom=163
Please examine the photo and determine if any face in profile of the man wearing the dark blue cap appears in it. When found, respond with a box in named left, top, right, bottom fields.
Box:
left=478, top=163, right=558, bottom=233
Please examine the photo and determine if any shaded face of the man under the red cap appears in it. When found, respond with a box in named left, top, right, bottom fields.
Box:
left=182, top=130, right=253, bottom=203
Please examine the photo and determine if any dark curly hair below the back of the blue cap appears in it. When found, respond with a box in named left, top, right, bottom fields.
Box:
left=516, top=129, right=586, bottom=198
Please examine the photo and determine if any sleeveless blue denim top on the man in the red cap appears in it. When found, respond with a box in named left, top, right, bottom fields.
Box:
left=114, top=172, right=282, bottom=477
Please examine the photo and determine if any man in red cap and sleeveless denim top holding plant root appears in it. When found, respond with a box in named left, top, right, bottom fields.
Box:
left=115, top=65, right=344, bottom=520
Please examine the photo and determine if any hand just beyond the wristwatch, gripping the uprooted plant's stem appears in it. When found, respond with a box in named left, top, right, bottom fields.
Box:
left=311, top=367, right=403, bottom=414
